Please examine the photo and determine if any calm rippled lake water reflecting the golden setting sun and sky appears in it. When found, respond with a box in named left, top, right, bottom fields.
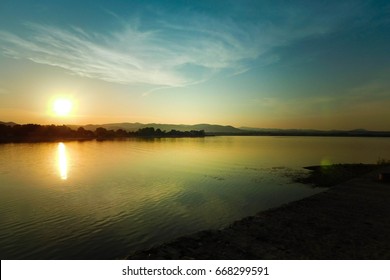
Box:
left=0, top=137, right=390, bottom=259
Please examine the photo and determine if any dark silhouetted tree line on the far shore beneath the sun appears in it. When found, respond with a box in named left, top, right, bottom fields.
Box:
left=0, top=124, right=205, bottom=142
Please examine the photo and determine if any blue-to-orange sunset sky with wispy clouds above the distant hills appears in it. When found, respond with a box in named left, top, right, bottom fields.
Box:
left=0, top=0, right=390, bottom=130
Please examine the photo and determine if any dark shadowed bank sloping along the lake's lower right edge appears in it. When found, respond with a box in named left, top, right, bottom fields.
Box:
left=128, top=167, right=390, bottom=259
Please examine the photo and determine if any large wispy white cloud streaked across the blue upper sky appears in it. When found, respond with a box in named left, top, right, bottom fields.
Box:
left=0, top=5, right=352, bottom=88
